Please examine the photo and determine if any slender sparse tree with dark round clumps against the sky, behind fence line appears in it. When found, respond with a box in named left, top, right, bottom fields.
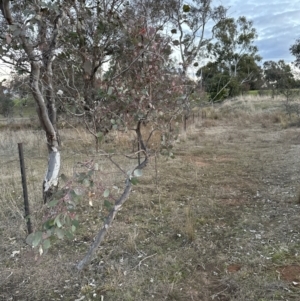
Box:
left=166, top=0, right=227, bottom=116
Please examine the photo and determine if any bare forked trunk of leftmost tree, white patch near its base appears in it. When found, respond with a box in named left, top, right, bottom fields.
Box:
left=0, top=0, right=64, bottom=202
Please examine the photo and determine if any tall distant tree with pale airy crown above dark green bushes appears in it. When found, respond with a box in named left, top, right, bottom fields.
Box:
left=202, top=17, right=261, bottom=101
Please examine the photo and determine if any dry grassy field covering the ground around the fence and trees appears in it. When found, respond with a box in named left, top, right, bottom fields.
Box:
left=0, top=97, right=300, bottom=301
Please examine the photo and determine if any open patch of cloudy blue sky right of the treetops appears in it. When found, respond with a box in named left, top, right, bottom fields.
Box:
left=220, top=0, right=300, bottom=63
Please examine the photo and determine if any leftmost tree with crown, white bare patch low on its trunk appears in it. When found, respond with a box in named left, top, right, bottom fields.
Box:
left=0, top=0, right=68, bottom=201
